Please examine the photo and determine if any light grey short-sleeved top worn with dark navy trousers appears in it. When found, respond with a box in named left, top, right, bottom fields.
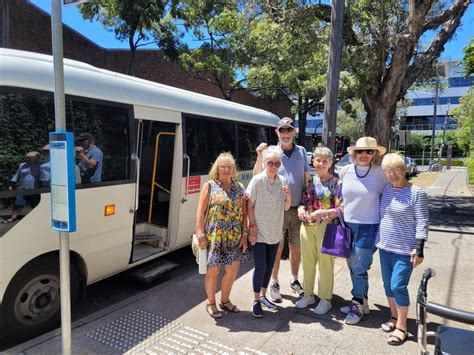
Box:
left=246, top=171, right=288, bottom=244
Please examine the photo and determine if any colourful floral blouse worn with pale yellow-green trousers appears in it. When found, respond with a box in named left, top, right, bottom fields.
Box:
left=301, top=175, right=343, bottom=226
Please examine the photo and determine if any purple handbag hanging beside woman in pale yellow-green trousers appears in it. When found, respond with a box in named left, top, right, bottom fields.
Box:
left=321, top=208, right=352, bottom=259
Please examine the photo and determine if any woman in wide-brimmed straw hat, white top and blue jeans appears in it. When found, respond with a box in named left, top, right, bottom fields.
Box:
left=340, top=137, right=387, bottom=324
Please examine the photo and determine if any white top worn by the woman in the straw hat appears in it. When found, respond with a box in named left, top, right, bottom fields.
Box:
left=340, top=164, right=387, bottom=224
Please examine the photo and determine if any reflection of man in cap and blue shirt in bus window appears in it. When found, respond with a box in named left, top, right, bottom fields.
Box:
left=75, top=133, right=103, bottom=183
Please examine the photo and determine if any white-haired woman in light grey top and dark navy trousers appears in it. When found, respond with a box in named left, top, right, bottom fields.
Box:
left=247, top=145, right=291, bottom=318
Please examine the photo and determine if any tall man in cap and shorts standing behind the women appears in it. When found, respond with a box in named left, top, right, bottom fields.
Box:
left=253, top=117, right=311, bottom=302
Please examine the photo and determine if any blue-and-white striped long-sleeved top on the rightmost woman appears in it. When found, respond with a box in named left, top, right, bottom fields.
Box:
left=375, top=183, right=428, bottom=255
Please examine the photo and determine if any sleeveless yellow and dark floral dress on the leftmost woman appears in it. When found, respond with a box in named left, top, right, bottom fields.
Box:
left=205, top=180, right=248, bottom=266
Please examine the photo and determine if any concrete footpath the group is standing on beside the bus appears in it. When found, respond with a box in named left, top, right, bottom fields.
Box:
left=6, top=169, right=474, bottom=354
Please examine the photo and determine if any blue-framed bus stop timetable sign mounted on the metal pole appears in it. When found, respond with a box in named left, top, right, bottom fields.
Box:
left=49, top=132, right=76, bottom=232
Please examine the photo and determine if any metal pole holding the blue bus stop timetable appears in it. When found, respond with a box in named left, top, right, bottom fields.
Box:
left=51, top=0, right=71, bottom=355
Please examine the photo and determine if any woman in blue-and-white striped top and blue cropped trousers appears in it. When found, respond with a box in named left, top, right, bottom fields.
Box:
left=376, top=154, right=428, bottom=345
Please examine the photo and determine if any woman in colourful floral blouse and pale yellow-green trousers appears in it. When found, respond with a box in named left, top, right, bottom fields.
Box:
left=295, top=147, right=342, bottom=314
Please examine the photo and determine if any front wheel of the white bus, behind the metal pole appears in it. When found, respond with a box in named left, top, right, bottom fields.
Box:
left=0, top=257, right=79, bottom=341
